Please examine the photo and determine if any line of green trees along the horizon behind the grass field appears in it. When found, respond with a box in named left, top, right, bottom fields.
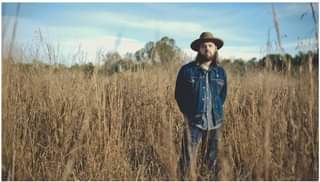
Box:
left=11, top=36, right=318, bottom=77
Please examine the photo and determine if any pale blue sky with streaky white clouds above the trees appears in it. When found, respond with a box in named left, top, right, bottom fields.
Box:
left=2, top=3, right=319, bottom=64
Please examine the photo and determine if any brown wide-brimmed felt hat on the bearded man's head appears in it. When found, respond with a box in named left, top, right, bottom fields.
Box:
left=191, top=32, right=223, bottom=51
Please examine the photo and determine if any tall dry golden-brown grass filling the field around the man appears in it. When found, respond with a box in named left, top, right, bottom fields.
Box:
left=2, top=58, right=318, bottom=180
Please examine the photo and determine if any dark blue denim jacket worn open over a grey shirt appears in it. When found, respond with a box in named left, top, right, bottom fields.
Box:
left=175, top=61, right=227, bottom=125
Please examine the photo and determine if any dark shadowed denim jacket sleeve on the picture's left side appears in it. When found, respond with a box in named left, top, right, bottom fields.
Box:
left=175, top=67, right=187, bottom=115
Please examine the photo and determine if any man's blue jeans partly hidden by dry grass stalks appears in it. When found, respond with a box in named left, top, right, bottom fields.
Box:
left=179, top=121, right=222, bottom=180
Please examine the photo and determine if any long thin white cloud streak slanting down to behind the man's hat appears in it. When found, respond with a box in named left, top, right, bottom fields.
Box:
left=70, top=12, right=252, bottom=43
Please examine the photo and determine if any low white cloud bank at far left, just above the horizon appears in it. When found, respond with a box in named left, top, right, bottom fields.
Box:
left=3, top=17, right=144, bottom=62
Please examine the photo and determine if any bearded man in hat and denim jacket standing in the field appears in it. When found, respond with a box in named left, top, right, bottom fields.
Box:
left=175, top=32, right=227, bottom=180
